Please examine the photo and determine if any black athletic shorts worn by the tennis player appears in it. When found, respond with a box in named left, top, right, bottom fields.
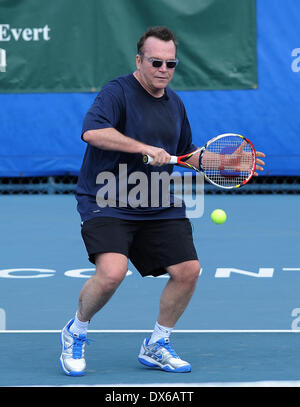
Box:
left=81, top=217, right=198, bottom=276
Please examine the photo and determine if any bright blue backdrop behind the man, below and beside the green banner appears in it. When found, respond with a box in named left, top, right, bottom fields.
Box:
left=0, top=0, right=300, bottom=177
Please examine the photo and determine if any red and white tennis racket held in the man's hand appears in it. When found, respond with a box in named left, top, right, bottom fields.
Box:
left=143, top=133, right=256, bottom=189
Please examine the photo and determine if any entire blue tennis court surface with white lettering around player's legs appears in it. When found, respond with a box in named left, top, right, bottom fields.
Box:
left=0, top=194, right=300, bottom=386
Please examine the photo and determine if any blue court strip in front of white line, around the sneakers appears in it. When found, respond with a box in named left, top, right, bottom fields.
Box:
left=0, top=332, right=300, bottom=386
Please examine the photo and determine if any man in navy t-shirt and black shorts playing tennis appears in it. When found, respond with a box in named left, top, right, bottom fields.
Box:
left=60, top=27, right=266, bottom=376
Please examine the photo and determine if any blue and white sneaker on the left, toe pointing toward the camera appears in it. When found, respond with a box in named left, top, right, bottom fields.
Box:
left=59, top=319, right=89, bottom=376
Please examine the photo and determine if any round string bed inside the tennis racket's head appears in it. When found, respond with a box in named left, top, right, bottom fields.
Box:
left=201, top=136, right=255, bottom=187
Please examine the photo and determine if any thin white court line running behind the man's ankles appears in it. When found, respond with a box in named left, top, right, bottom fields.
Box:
left=0, top=329, right=300, bottom=334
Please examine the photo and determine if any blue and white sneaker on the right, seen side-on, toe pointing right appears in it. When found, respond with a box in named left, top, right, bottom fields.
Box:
left=138, top=338, right=192, bottom=373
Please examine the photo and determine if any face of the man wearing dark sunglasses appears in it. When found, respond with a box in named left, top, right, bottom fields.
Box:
left=136, top=37, right=176, bottom=94
